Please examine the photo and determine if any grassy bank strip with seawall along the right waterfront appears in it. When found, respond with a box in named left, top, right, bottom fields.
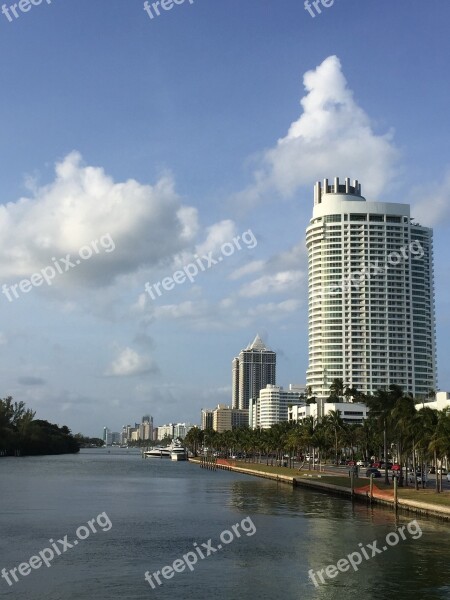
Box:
left=189, top=457, right=450, bottom=520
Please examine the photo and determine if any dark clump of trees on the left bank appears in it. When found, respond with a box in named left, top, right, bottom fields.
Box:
left=0, top=396, right=80, bottom=457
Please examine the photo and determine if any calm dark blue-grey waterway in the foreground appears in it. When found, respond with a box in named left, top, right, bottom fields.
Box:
left=0, top=450, right=450, bottom=600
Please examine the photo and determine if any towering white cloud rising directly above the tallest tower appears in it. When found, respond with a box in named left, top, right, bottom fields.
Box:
left=237, top=56, right=399, bottom=204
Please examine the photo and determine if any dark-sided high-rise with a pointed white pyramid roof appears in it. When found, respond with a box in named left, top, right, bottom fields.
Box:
left=232, top=335, right=277, bottom=410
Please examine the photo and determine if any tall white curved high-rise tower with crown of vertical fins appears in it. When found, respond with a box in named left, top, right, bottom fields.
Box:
left=306, top=178, right=436, bottom=399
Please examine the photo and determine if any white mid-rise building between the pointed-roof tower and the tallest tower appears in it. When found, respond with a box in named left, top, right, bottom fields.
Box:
left=249, top=384, right=306, bottom=429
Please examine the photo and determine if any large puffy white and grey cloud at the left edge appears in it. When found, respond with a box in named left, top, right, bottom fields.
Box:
left=0, top=152, right=198, bottom=286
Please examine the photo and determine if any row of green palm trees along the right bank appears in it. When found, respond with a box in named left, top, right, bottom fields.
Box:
left=185, top=379, right=450, bottom=492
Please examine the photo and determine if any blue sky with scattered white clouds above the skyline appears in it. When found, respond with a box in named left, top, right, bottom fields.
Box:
left=0, top=0, right=450, bottom=436
